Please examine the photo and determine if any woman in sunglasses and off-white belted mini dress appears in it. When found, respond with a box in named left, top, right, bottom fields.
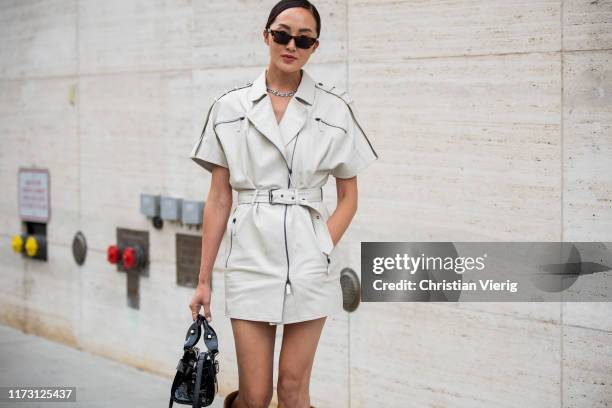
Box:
left=190, top=0, right=378, bottom=408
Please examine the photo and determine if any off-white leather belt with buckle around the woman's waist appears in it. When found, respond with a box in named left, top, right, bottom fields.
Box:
left=238, top=187, right=334, bottom=255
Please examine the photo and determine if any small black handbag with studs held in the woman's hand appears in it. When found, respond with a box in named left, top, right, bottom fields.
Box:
left=169, top=313, right=219, bottom=408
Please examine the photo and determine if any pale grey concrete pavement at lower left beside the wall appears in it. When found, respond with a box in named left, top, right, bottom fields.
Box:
left=0, top=325, right=224, bottom=408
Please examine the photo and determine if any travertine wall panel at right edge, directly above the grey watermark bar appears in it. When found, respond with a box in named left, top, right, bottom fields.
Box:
left=563, top=51, right=612, bottom=241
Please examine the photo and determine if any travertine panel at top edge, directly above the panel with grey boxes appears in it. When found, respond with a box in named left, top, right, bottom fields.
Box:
left=78, top=0, right=193, bottom=74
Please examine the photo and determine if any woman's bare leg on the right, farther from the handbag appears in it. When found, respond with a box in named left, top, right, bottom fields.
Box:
left=276, top=317, right=326, bottom=408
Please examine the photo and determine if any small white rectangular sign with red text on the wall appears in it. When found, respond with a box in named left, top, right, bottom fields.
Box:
left=18, top=167, right=50, bottom=223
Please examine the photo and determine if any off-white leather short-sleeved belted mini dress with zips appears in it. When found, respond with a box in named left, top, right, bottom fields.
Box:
left=191, top=69, right=378, bottom=324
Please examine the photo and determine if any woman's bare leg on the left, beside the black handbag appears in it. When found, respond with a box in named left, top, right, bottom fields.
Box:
left=231, top=318, right=276, bottom=408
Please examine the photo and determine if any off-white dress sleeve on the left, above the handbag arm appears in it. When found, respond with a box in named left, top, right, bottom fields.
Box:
left=190, top=101, right=229, bottom=173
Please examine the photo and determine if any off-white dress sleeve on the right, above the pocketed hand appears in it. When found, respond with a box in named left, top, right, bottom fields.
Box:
left=331, top=96, right=378, bottom=178
